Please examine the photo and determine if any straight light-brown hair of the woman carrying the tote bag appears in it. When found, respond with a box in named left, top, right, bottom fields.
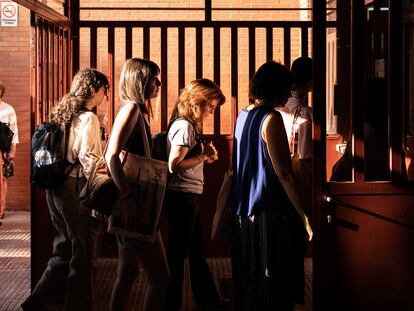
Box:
left=119, top=58, right=160, bottom=114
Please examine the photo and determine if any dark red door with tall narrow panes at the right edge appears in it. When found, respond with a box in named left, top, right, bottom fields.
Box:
left=314, top=0, right=414, bottom=311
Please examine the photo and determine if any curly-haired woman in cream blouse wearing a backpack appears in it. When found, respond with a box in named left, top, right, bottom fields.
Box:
left=21, top=69, right=109, bottom=311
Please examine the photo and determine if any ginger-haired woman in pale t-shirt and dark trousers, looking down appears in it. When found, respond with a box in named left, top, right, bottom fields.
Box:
left=164, top=79, right=230, bottom=311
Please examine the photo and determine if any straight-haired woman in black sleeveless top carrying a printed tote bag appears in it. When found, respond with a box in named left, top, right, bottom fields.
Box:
left=105, top=58, right=169, bottom=311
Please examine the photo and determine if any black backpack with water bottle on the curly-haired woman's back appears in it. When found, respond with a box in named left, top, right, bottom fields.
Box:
left=30, top=114, right=79, bottom=189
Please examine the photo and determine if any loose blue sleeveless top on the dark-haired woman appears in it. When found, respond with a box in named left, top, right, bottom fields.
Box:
left=233, top=106, right=289, bottom=216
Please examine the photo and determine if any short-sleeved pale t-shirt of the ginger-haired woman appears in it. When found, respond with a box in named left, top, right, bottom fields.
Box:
left=167, top=119, right=204, bottom=194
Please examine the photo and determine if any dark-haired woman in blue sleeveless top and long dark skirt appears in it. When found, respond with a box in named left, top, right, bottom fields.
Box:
left=232, top=61, right=312, bottom=311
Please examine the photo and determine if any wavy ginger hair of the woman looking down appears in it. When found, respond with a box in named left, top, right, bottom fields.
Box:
left=170, top=79, right=226, bottom=133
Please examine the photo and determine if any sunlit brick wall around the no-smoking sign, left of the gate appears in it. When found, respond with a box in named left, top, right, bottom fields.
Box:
left=0, top=5, right=31, bottom=210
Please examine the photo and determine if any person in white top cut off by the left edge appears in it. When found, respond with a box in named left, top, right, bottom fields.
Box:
left=0, top=81, right=19, bottom=223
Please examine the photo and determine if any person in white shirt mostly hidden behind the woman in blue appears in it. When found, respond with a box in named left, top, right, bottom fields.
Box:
left=277, top=56, right=313, bottom=216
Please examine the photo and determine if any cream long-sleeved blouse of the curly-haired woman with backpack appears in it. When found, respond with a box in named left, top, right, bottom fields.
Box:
left=66, top=111, right=102, bottom=178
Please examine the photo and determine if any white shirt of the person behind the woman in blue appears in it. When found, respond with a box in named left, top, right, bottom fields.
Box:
left=277, top=92, right=313, bottom=159
